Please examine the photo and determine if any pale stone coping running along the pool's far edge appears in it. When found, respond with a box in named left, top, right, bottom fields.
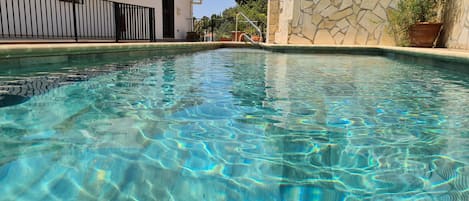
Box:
left=0, top=42, right=469, bottom=68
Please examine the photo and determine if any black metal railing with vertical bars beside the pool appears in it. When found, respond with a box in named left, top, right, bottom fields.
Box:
left=0, top=0, right=155, bottom=42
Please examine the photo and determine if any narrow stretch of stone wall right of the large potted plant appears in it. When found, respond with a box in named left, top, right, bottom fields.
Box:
left=442, top=0, right=469, bottom=50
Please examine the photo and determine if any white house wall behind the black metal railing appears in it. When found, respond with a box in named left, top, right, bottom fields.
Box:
left=0, top=0, right=193, bottom=40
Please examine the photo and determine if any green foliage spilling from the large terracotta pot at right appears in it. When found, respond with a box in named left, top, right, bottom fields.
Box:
left=388, top=0, right=445, bottom=46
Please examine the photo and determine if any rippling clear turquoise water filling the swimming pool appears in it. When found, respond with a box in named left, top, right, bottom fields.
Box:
left=0, top=49, right=469, bottom=201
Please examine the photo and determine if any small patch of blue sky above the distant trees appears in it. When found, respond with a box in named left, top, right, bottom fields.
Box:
left=194, top=0, right=236, bottom=18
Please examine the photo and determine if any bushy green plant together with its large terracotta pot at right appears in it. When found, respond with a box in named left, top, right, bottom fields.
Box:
left=389, top=0, right=445, bottom=47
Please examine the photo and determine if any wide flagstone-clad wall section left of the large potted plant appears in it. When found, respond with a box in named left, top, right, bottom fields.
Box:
left=269, top=0, right=398, bottom=45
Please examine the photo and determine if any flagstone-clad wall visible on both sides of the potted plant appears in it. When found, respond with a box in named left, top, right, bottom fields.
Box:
left=267, top=0, right=469, bottom=49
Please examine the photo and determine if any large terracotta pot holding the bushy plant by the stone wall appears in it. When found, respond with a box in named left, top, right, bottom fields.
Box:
left=409, top=22, right=443, bottom=47
